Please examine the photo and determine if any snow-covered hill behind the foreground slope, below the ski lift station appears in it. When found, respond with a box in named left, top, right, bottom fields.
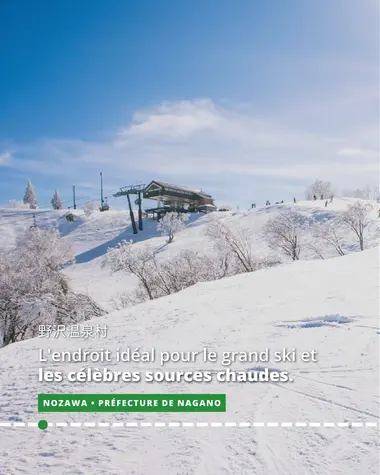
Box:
left=0, top=198, right=379, bottom=310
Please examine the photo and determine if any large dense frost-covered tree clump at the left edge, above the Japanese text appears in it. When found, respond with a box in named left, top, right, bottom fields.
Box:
left=0, top=227, right=104, bottom=347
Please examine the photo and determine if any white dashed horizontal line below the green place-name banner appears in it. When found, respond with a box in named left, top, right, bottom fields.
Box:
left=0, top=422, right=380, bottom=428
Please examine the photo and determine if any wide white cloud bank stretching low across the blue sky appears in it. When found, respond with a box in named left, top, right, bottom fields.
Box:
left=4, top=99, right=378, bottom=201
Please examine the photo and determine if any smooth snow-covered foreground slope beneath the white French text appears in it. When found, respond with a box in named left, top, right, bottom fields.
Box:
left=0, top=247, right=380, bottom=475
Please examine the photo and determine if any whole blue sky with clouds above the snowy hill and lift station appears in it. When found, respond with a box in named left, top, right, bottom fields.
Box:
left=0, top=0, right=379, bottom=206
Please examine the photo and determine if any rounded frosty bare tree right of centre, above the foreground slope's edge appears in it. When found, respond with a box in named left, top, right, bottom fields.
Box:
left=264, top=211, right=304, bottom=261
